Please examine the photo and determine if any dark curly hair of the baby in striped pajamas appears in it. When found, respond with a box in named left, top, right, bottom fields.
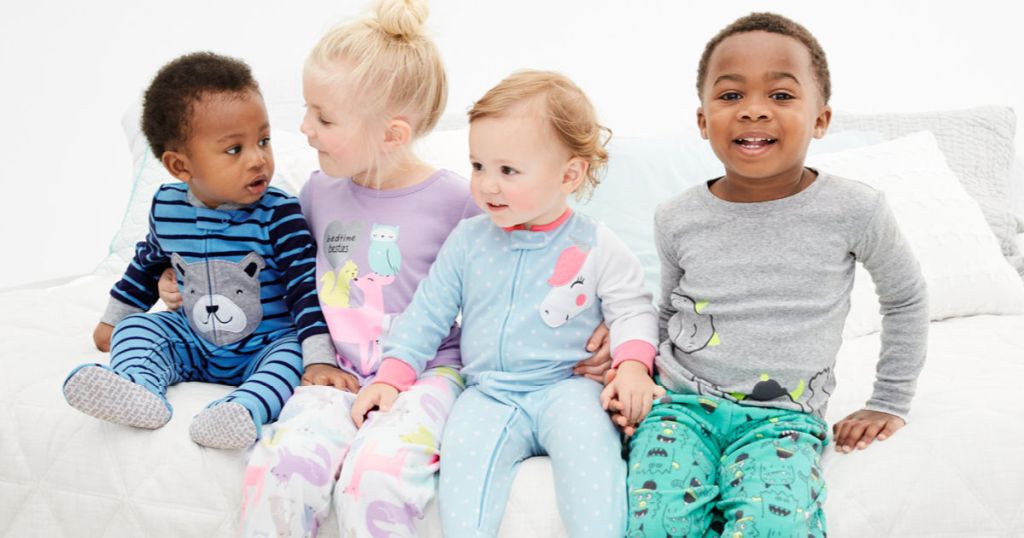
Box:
left=142, top=52, right=259, bottom=159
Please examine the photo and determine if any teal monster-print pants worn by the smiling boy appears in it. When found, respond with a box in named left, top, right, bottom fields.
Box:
left=628, top=391, right=828, bottom=538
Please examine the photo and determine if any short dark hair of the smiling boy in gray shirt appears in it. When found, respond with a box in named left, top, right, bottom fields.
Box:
left=697, top=12, right=831, bottom=105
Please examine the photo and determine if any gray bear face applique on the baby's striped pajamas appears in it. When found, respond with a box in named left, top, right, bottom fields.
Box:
left=171, top=252, right=266, bottom=345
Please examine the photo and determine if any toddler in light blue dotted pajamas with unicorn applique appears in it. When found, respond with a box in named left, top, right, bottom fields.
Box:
left=352, top=72, right=657, bottom=538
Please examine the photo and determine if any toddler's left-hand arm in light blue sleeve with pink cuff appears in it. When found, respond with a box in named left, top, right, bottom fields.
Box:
left=352, top=221, right=466, bottom=427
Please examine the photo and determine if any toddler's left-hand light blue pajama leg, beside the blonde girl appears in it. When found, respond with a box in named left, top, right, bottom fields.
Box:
left=437, top=386, right=540, bottom=538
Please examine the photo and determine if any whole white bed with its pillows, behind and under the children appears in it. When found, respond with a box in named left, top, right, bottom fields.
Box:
left=0, top=104, right=1024, bottom=538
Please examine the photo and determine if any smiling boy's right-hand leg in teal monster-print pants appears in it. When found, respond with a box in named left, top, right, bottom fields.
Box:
left=718, top=408, right=827, bottom=537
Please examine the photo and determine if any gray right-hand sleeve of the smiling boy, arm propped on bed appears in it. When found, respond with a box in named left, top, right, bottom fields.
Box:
left=853, top=194, right=928, bottom=420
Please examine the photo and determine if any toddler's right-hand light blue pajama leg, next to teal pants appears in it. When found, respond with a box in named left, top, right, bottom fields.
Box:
left=537, top=377, right=626, bottom=538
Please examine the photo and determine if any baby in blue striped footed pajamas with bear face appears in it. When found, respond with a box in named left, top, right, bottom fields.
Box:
left=63, top=52, right=335, bottom=449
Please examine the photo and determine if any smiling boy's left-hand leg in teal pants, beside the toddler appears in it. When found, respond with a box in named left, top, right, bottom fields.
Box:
left=627, top=392, right=721, bottom=538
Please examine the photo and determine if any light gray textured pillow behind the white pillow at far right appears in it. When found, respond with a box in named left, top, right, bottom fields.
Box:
left=829, top=107, right=1024, bottom=277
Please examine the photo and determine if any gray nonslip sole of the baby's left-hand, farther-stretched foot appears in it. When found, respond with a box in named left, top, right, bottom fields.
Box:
left=63, top=366, right=171, bottom=429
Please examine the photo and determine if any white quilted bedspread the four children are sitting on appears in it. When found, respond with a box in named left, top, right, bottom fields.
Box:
left=0, top=276, right=1024, bottom=538
